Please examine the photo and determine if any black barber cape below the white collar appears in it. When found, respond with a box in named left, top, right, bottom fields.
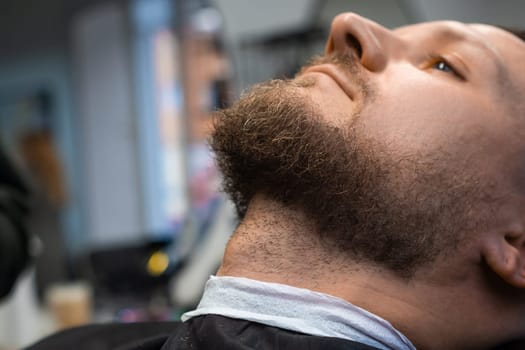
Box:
left=26, top=315, right=377, bottom=350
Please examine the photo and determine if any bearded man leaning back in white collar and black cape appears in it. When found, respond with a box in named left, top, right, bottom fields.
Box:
left=27, top=13, right=525, bottom=350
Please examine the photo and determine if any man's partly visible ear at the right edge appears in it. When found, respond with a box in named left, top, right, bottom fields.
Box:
left=482, top=231, right=525, bottom=289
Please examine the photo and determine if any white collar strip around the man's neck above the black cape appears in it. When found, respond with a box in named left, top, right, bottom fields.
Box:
left=182, top=276, right=416, bottom=350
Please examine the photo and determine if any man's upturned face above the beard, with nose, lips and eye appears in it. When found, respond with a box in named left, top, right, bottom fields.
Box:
left=298, top=14, right=525, bottom=173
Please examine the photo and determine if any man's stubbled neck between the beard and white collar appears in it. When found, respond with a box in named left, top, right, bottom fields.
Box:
left=217, top=197, right=520, bottom=350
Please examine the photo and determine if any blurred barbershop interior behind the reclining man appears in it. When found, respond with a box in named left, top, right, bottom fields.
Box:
left=0, top=0, right=525, bottom=349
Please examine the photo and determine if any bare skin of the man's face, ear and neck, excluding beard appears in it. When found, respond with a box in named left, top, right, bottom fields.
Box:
left=218, top=13, right=525, bottom=349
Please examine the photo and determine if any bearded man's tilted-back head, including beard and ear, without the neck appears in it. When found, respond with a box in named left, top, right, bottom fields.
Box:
left=212, top=14, right=525, bottom=287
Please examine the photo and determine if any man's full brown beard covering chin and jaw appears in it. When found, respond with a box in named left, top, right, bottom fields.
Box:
left=210, top=56, right=479, bottom=278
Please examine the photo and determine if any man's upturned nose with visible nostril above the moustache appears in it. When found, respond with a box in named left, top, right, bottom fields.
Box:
left=325, top=13, right=399, bottom=72
